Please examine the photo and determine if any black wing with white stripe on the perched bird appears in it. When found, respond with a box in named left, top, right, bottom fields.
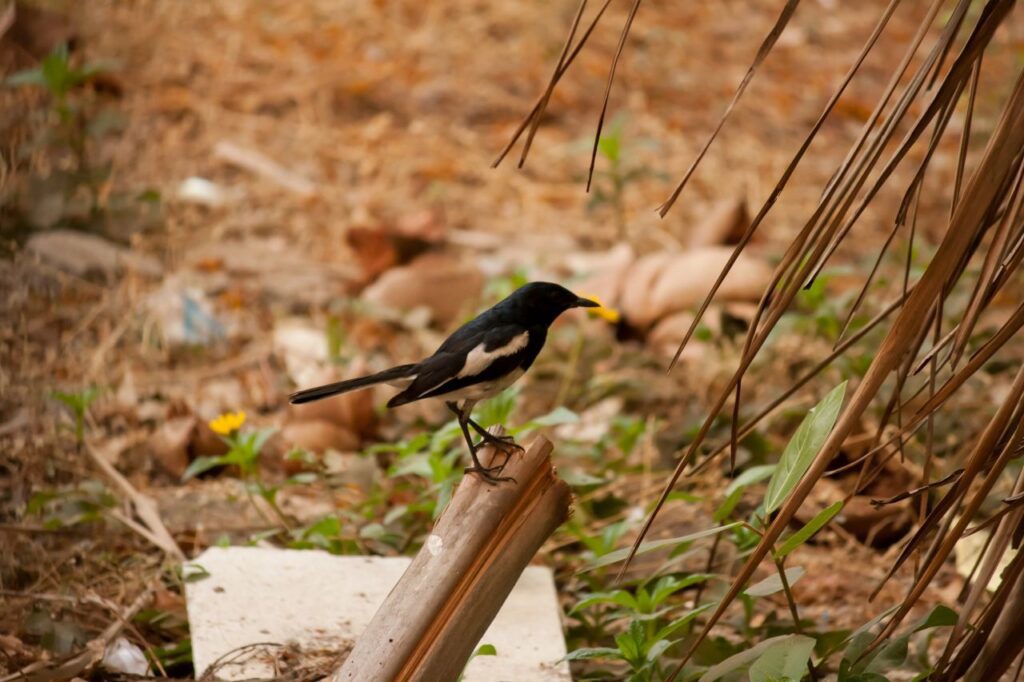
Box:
left=388, top=325, right=536, bottom=408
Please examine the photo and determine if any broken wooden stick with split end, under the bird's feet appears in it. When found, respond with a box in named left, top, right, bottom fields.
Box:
left=333, top=436, right=571, bottom=682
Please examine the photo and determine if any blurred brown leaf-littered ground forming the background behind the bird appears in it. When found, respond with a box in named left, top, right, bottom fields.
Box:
left=0, top=0, right=1024, bottom=675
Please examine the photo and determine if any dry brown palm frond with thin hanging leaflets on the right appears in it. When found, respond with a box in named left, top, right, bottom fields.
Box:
left=501, top=0, right=1024, bottom=679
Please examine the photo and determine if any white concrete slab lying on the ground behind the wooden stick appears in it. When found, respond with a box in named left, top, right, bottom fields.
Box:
left=185, top=547, right=572, bottom=682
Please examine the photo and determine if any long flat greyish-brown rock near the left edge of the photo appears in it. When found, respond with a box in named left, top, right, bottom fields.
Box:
left=26, top=229, right=164, bottom=278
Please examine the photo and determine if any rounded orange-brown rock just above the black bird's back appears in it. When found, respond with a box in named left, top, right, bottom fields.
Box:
left=362, top=253, right=483, bottom=327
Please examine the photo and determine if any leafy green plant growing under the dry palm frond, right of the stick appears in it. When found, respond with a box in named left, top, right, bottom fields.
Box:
left=568, top=383, right=860, bottom=682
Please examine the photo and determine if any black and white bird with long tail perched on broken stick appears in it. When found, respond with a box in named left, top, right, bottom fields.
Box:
left=290, top=282, right=600, bottom=483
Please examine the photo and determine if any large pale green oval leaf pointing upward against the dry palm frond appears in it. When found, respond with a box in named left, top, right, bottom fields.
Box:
left=764, top=381, right=847, bottom=514
